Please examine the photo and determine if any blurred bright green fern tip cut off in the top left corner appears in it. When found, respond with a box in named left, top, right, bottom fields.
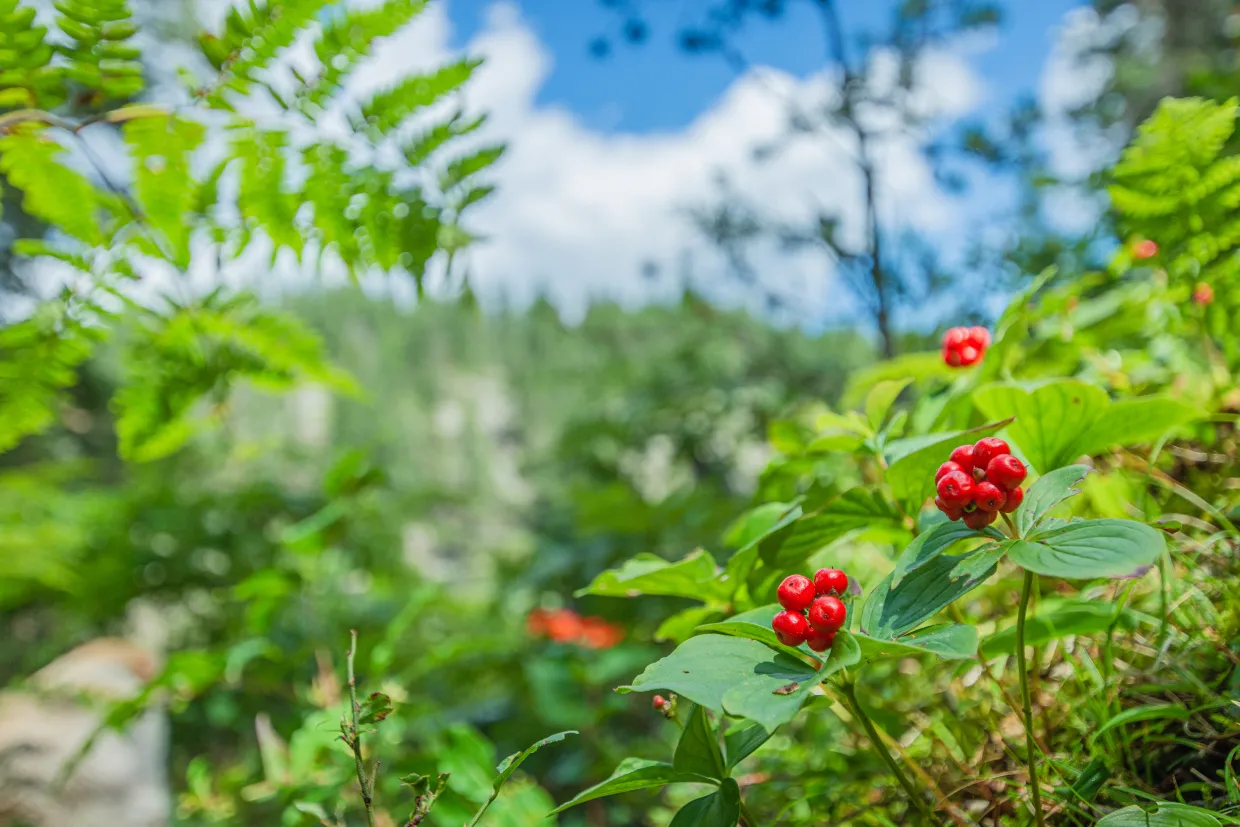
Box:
left=0, top=0, right=64, bottom=110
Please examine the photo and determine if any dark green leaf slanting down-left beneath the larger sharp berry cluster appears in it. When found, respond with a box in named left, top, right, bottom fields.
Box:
left=861, top=548, right=997, bottom=640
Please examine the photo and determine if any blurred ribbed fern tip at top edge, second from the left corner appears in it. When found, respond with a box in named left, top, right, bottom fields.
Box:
left=56, top=0, right=145, bottom=104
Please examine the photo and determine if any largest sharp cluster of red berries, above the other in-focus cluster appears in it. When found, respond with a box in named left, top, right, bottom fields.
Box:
left=934, top=436, right=1029, bottom=531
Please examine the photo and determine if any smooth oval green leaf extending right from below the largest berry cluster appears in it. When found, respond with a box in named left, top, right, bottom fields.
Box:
left=1007, top=520, right=1167, bottom=580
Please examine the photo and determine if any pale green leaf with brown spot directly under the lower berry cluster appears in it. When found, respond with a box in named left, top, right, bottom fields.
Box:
left=723, top=629, right=861, bottom=733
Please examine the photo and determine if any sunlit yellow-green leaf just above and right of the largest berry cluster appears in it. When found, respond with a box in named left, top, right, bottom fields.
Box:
left=973, top=379, right=1110, bottom=474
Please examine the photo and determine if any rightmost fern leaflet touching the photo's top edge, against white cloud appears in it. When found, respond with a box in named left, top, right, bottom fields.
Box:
left=299, top=0, right=427, bottom=108
